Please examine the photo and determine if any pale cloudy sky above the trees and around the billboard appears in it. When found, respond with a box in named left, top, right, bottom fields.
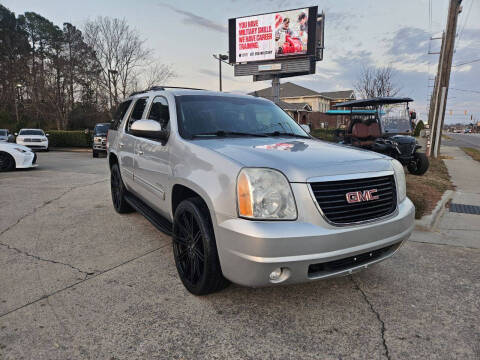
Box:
left=0, top=0, right=480, bottom=123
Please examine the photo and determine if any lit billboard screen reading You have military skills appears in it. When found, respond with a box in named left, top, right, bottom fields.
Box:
left=229, top=6, right=317, bottom=63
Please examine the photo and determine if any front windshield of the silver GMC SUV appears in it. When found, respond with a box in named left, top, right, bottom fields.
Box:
left=176, top=95, right=309, bottom=139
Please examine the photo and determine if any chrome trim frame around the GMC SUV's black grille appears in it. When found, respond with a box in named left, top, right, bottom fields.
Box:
left=307, top=170, right=399, bottom=227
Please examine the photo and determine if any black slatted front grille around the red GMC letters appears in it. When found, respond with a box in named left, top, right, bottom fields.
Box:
left=310, top=175, right=397, bottom=224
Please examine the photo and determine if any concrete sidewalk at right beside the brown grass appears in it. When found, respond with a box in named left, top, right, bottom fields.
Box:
left=416, top=146, right=480, bottom=248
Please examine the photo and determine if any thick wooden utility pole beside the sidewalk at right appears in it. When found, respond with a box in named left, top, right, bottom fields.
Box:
left=431, top=0, right=462, bottom=157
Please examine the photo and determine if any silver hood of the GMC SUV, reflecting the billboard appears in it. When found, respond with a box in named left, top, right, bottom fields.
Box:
left=195, top=137, right=392, bottom=182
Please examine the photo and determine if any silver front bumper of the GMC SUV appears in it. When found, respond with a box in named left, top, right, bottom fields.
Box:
left=214, top=184, right=415, bottom=287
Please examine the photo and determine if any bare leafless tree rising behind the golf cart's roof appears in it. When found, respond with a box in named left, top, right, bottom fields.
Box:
left=354, top=65, right=401, bottom=99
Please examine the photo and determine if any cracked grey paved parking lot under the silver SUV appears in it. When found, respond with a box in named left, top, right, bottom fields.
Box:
left=0, top=152, right=480, bottom=360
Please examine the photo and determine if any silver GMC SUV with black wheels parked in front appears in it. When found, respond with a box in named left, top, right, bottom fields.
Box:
left=107, top=87, right=414, bottom=295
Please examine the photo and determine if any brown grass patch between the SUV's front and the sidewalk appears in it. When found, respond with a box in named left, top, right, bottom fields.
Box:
left=405, top=158, right=453, bottom=219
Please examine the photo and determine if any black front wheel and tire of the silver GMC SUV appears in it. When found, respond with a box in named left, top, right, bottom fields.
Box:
left=172, top=198, right=230, bottom=295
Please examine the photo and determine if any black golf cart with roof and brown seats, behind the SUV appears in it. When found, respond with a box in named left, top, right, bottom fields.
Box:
left=334, top=97, right=429, bottom=175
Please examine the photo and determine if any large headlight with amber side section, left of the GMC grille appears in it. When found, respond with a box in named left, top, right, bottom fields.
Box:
left=237, top=168, right=297, bottom=220
